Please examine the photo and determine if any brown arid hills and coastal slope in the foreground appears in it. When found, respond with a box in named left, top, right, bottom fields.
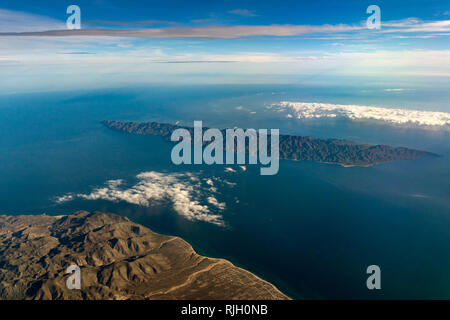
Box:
left=0, top=211, right=289, bottom=300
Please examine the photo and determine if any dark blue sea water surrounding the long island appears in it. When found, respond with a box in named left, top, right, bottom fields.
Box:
left=0, top=86, right=450, bottom=299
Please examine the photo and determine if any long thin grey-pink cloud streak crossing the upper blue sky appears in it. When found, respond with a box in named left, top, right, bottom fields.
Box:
left=0, top=20, right=450, bottom=39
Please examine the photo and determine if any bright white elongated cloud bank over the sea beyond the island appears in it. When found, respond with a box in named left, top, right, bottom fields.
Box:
left=272, top=101, right=450, bottom=129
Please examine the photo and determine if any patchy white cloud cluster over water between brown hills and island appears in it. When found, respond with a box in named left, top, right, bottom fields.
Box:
left=56, top=171, right=226, bottom=226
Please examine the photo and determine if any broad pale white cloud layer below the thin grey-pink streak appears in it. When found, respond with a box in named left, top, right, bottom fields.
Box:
left=0, top=44, right=450, bottom=77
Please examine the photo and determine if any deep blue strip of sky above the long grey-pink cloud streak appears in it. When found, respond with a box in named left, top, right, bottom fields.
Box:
left=2, top=0, right=450, bottom=25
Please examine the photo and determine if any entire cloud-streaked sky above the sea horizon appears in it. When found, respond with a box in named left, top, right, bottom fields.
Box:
left=0, top=0, right=450, bottom=93
